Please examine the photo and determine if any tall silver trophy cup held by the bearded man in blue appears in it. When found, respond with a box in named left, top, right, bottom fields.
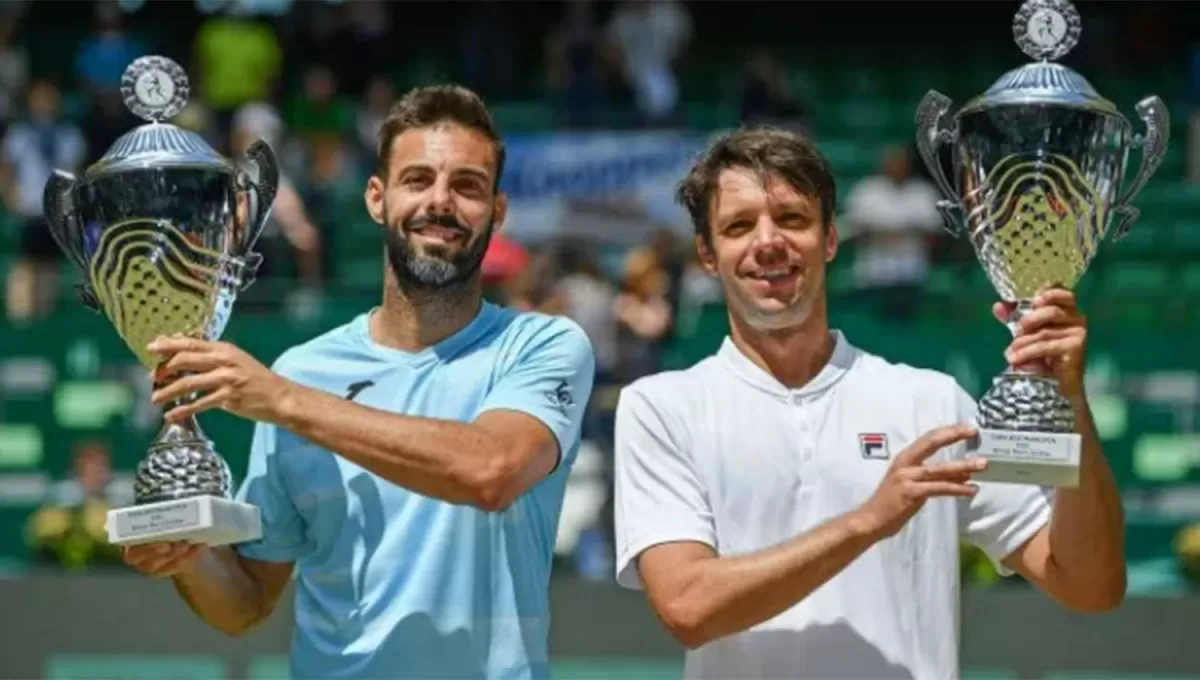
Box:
left=43, top=56, right=278, bottom=546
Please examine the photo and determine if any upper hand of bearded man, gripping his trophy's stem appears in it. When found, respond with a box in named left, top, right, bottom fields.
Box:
left=146, top=337, right=293, bottom=422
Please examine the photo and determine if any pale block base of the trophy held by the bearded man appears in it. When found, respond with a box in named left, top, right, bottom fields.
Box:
left=106, top=495, right=263, bottom=547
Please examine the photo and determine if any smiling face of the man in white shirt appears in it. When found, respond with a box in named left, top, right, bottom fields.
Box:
left=696, top=167, right=838, bottom=331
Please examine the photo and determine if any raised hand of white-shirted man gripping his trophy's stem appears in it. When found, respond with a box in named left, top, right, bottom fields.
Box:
left=994, top=288, right=1087, bottom=398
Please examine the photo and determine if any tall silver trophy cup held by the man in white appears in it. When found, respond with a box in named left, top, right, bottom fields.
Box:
left=916, top=0, right=1170, bottom=487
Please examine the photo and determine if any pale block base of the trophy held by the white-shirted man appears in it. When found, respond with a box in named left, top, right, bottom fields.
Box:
left=967, top=428, right=1082, bottom=488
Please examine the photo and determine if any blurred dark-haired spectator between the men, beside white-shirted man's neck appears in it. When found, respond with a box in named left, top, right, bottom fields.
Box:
left=613, top=248, right=674, bottom=383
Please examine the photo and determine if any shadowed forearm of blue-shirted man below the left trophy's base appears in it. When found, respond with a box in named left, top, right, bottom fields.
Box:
left=174, top=547, right=271, bottom=636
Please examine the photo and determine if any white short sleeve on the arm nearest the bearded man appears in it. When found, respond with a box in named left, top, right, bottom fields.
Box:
left=614, top=385, right=716, bottom=589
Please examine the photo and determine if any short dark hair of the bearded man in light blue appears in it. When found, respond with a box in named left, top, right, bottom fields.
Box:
left=376, top=85, right=505, bottom=191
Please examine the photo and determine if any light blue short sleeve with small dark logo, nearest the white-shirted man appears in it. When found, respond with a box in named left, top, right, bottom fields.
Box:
left=480, top=318, right=595, bottom=469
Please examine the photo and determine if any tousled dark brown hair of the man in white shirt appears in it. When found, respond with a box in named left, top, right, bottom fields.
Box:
left=676, top=127, right=838, bottom=242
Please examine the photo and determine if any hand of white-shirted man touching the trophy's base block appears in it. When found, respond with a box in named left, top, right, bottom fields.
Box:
left=858, top=425, right=988, bottom=538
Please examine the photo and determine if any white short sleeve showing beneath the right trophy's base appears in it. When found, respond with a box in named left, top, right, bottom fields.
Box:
left=956, top=387, right=1054, bottom=576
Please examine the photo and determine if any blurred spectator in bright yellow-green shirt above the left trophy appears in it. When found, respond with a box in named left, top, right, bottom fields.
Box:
left=192, top=2, right=283, bottom=149
